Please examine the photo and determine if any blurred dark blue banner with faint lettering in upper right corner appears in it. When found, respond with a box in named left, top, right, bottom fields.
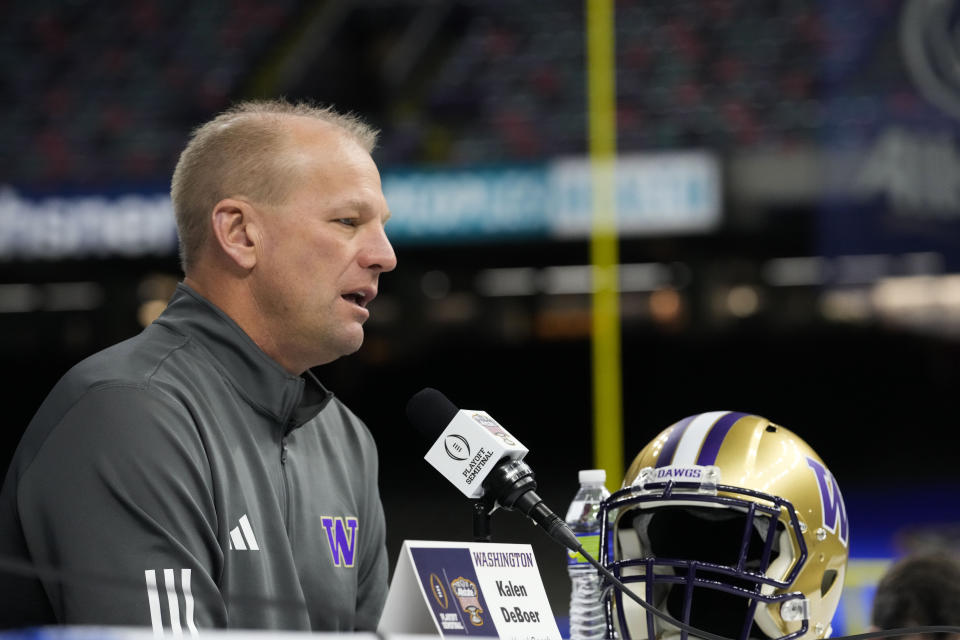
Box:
left=819, top=0, right=960, bottom=271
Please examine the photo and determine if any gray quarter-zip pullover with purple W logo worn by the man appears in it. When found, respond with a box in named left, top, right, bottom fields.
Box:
left=0, top=284, right=388, bottom=634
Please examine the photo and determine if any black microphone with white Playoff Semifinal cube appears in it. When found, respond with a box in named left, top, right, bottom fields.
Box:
left=407, top=387, right=581, bottom=551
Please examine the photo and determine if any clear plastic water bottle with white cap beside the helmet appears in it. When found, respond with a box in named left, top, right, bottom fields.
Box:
left=567, top=469, right=610, bottom=640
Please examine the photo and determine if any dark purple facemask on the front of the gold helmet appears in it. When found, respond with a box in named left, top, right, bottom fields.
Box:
left=605, top=483, right=807, bottom=640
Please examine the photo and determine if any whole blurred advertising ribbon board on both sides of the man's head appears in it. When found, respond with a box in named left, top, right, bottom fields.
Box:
left=0, top=152, right=721, bottom=260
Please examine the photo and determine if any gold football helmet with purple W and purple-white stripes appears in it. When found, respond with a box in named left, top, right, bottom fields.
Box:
left=601, top=411, right=850, bottom=640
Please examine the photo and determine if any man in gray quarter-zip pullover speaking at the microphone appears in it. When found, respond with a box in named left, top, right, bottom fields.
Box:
left=0, top=102, right=396, bottom=634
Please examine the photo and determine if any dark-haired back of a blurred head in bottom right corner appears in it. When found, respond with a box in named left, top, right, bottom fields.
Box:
left=871, top=550, right=960, bottom=640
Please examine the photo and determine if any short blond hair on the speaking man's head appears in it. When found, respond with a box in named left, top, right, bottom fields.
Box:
left=170, top=100, right=378, bottom=273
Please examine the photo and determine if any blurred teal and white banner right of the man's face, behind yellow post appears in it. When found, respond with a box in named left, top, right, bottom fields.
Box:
left=383, top=151, right=722, bottom=243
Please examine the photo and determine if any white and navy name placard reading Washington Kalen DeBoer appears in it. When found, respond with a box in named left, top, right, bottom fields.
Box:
left=377, top=540, right=560, bottom=640
